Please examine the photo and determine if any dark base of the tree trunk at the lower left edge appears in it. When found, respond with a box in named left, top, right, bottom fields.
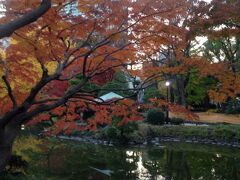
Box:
left=0, top=125, right=20, bottom=173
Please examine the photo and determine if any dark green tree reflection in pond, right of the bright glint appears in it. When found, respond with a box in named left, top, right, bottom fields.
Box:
left=143, top=146, right=240, bottom=180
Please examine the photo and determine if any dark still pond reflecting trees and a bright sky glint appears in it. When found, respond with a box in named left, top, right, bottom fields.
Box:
left=5, top=141, right=240, bottom=180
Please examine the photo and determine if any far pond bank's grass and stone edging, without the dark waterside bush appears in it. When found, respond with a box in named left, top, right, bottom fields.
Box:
left=55, top=123, right=240, bottom=149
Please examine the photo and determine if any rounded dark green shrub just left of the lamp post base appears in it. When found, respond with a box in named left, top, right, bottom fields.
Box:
left=147, top=109, right=166, bottom=125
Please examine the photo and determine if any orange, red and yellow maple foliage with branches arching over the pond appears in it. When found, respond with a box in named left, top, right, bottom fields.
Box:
left=0, top=0, right=240, bottom=136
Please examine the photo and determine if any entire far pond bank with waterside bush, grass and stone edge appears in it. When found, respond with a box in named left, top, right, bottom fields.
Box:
left=24, top=122, right=240, bottom=145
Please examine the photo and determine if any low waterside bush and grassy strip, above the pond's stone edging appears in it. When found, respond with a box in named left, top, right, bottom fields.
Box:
left=96, top=120, right=240, bottom=144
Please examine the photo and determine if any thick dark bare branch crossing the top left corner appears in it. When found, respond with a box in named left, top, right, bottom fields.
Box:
left=0, top=0, right=51, bottom=38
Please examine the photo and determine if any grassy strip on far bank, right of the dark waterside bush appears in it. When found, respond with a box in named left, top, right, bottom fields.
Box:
left=129, top=123, right=240, bottom=142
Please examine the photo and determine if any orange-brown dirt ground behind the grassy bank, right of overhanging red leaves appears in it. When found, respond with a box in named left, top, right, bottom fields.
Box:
left=196, top=112, right=240, bottom=124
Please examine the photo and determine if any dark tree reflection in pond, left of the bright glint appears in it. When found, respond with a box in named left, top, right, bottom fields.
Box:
left=38, top=144, right=139, bottom=179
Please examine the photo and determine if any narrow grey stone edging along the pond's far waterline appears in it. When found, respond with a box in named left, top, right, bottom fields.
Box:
left=56, top=136, right=240, bottom=148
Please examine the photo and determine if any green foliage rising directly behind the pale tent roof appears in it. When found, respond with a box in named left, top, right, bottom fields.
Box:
left=98, top=71, right=132, bottom=97
